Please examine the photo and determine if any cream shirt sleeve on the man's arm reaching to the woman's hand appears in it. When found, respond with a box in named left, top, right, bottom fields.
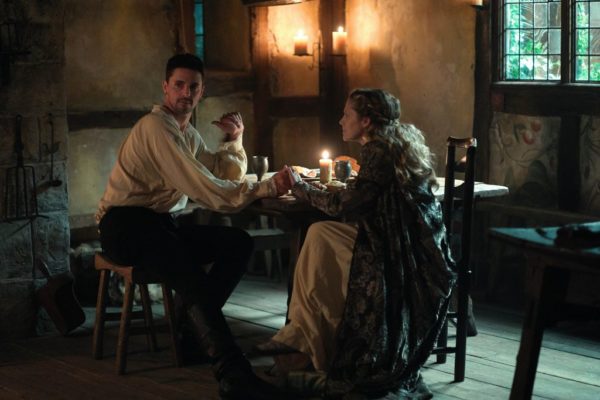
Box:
left=146, top=117, right=277, bottom=212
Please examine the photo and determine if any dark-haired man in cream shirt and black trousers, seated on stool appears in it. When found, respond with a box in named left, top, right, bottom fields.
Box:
left=96, top=54, right=289, bottom=399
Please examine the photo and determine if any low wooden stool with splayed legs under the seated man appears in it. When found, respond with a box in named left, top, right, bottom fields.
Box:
left=92, top=252, right=182, bottom=375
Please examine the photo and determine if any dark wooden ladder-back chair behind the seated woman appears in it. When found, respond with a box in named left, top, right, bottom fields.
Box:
left=433, top=137, right=477, bottom=382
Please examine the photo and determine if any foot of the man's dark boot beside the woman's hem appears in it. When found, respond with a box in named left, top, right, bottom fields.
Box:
left=219, top=369, right=294, bottom=400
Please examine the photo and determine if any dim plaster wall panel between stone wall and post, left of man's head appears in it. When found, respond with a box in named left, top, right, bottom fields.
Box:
left=65, top=0, right=175, bottom=112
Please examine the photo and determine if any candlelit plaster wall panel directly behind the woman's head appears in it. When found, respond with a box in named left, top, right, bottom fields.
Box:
left=346, top=0, right=475, bottom=173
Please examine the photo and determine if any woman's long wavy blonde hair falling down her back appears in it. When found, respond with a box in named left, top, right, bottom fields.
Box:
left=348, top=89, right=436, bottom=186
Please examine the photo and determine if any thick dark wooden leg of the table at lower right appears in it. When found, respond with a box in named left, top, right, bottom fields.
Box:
left=510, top=265, right=569, bottom=400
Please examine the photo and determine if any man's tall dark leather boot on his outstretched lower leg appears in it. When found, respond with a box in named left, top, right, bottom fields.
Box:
left=188, top=305, right=292, bottom=400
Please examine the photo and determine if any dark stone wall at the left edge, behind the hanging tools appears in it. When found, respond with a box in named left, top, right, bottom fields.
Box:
left=0, top=0, right=69, bottom=340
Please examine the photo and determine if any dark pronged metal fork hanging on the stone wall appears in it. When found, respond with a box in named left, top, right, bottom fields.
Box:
left=4, top=115, right=39, bottom=221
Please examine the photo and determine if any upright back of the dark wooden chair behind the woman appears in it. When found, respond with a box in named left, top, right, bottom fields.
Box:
left=442, top=136, right=477, bottom=273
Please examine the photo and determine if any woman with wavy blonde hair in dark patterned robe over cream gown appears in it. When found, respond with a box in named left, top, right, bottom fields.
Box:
left=257, top=89, right=455, bottom=399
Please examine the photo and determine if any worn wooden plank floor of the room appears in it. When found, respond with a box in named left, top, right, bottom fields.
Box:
left=0, top=278, right=600, bottom=400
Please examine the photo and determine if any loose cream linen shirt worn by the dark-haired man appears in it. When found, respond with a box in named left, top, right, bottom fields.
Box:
left=96, top=105, right=277, bottom=222
